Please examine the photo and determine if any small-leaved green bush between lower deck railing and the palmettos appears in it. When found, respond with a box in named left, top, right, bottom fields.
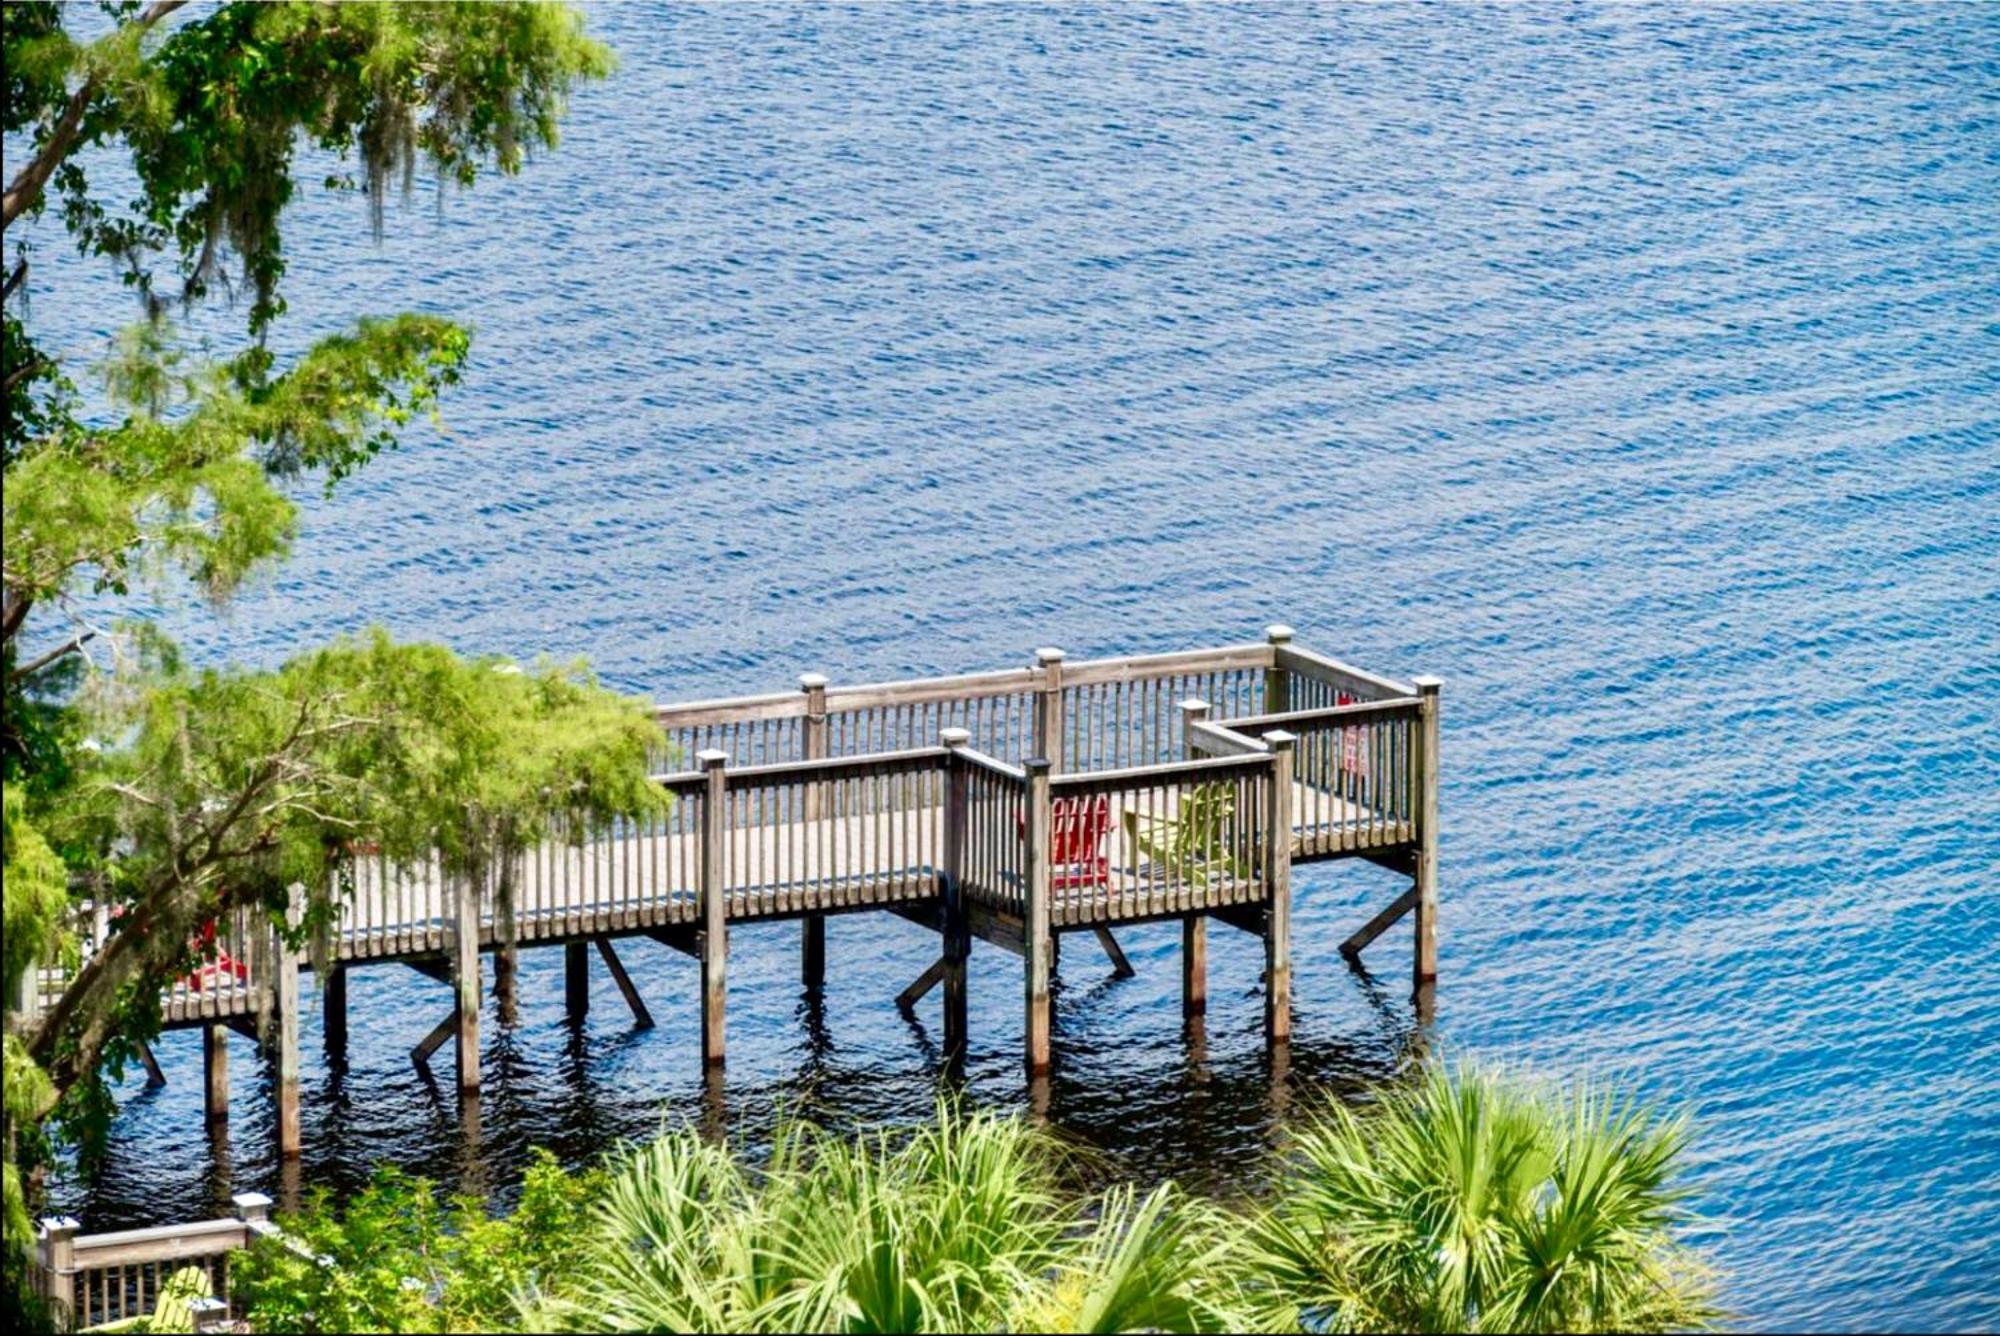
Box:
left=230, top=1152, right=602, bottom=1332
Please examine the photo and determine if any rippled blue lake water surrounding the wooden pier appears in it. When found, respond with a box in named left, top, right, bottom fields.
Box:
left=19, top=6, right=2000, bottom=1328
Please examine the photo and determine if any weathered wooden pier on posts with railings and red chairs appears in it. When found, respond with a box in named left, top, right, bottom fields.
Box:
left=27, top=626, right=1440, bottom=1156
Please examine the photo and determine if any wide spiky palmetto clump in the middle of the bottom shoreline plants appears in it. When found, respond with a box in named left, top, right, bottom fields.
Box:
left=526, top=1104, right=1244, bottom=1332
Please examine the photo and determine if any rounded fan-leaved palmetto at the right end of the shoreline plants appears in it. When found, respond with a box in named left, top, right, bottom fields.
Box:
left=1248, top=1066, right=1720, bottom=1332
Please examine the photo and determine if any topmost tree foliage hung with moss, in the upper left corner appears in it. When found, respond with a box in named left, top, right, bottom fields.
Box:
left=6, top=0, right=612, bottom=332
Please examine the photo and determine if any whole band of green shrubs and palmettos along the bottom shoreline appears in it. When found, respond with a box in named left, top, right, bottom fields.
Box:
left=223, top=1064, right=1722, bottom=1332
